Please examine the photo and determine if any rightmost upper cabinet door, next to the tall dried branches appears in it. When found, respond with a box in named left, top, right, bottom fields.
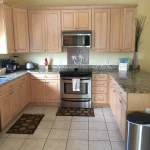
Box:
left=123, top=8, right=136, bottom=51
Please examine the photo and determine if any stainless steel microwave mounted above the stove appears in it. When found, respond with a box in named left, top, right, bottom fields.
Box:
left=62, top=30, right=92, bottom=47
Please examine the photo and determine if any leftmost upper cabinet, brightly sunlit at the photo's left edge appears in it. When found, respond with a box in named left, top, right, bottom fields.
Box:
left=0, top=4, right=15, bottom=54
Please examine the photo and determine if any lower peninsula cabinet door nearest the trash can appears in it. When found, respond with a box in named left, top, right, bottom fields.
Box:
left=121, top=101, right=127, bottom=141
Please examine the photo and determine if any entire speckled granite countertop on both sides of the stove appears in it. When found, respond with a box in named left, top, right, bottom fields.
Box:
left=0, top=68, right=150, bottom=93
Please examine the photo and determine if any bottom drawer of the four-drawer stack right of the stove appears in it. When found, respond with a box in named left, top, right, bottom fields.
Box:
left=92, top=94, right=107, bottom=103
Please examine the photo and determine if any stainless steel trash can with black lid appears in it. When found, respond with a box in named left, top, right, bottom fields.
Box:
left=126, top=112, right=150, bottom=150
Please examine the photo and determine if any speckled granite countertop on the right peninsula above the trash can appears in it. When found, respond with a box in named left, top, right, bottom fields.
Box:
left=109, top=71, right=150, bottom=93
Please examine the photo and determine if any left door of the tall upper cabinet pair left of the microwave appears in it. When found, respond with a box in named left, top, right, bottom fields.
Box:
left=29, top=10, right=46, bottom=52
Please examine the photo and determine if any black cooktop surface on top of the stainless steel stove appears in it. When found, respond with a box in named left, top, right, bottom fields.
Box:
left=60, top=68, right=92, bottom=77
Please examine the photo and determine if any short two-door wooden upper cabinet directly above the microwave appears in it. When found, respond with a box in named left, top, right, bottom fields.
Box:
left=61, top=9, right=91, bottom=30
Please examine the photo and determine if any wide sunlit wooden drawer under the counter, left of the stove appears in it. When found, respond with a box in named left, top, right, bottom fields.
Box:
left=31, top=74, right=60, bottom=79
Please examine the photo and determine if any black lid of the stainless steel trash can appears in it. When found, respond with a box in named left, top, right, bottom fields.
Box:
left=127, top=112, right=150, bottom=125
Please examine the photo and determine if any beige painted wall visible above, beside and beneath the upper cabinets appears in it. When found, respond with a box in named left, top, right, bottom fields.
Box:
left=2, top=0, right=150, bottom=69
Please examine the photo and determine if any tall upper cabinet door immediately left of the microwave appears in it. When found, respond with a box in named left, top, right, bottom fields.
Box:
left=45, top=10, right=61, bottom=52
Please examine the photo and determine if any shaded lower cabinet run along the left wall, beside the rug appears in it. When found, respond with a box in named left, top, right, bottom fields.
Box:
left=0, top=75, right=30, bottom=129
